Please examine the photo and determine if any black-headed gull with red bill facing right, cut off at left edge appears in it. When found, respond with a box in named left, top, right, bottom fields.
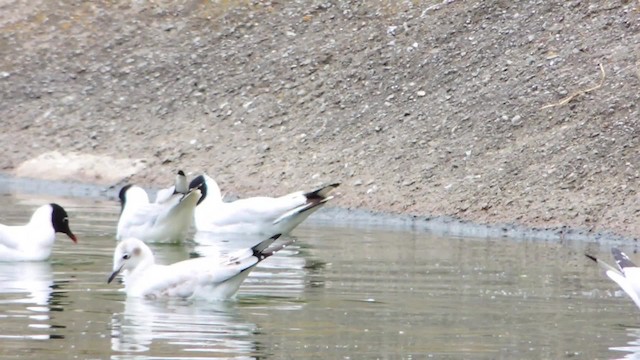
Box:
left=0, top=203, right=78, bottom=261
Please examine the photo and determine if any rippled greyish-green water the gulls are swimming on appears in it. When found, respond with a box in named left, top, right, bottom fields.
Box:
left=0, top=190, right=640, bottom=359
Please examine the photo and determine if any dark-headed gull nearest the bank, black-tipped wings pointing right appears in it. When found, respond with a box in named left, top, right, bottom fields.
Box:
left=189, top=174, right=340, bottom=236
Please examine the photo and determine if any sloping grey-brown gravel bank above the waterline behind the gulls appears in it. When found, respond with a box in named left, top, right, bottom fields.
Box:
left=0, top=0, right=640, bottom=238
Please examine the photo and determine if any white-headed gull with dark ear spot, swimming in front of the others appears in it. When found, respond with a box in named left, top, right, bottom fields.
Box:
left=107, top=234, right=290, bottom=300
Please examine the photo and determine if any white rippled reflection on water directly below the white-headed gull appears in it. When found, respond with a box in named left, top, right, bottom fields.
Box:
left=111, top=298, right=256, bottom=357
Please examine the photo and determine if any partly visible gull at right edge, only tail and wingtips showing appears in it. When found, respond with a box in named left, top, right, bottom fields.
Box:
left=585, top=248, right=640, bottom=308
